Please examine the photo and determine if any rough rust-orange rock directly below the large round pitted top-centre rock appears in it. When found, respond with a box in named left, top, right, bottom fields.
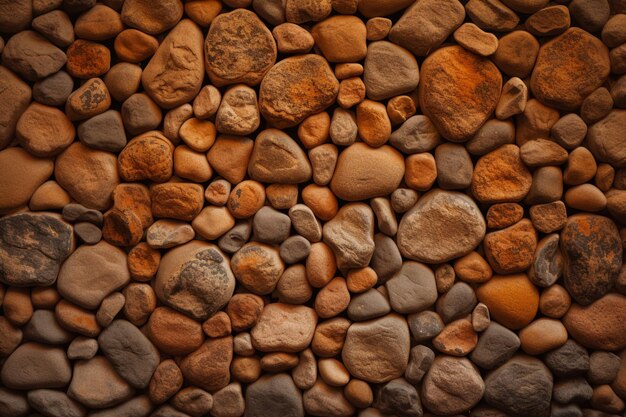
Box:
left=259, top=54, right=339, bottom=129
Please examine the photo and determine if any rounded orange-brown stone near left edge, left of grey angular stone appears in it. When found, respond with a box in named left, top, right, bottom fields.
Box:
left=15, top=103, right=76, bottom=158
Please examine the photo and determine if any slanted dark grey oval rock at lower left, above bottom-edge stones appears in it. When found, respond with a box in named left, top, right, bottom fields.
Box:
left=98, top=320, right=160, bottom=388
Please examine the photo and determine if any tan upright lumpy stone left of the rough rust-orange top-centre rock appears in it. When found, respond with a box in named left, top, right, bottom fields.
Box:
left=215, top=85, right=261, bottom=135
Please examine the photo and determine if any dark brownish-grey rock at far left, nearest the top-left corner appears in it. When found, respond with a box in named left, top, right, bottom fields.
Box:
left=2, top=30, right=67, bottom=81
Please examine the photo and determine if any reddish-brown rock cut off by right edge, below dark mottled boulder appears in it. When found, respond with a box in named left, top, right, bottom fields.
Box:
left=563, top=294, right=626, bottom=350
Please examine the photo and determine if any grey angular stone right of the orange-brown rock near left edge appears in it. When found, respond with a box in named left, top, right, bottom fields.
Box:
left=78, top=110, right=126, bottom=152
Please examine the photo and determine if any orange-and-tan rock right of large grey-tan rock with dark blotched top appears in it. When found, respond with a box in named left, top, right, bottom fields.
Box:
left=231, top=242, right=285, bottom=295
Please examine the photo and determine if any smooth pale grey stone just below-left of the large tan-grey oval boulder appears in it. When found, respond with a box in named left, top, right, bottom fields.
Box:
left=385, top=262, right=437, bottom=314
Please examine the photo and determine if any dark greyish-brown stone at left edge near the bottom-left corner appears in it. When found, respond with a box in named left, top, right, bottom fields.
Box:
left=0, top=343, right=72, bottom=390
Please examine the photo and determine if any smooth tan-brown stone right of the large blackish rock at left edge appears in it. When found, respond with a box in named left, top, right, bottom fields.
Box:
left=57, top=242, right=130, bottom=309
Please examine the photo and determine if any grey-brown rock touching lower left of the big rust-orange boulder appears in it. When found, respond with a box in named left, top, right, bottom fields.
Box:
left=389, top=114, right=441, bottom=154
